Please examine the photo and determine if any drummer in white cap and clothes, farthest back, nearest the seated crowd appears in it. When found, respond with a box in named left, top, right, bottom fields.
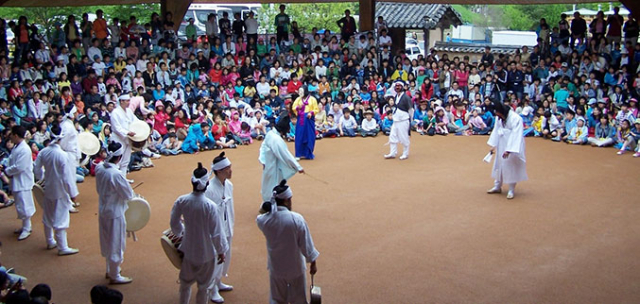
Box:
left=111, top=94, right=137, bottom=184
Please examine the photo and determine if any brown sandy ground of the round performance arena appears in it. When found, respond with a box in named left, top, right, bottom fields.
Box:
left=0, top=136, right=640, bottom=304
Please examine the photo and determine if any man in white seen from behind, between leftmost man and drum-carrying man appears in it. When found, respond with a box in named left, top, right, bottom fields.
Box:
left=34, top=125, right=79, bottom=255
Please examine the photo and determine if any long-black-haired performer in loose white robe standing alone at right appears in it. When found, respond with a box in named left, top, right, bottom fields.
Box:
left=487, top=104, right=527, bottom=199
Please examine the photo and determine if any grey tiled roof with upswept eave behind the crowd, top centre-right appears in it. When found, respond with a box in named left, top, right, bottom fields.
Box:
left=376, top=2, right=462, bottom=29
